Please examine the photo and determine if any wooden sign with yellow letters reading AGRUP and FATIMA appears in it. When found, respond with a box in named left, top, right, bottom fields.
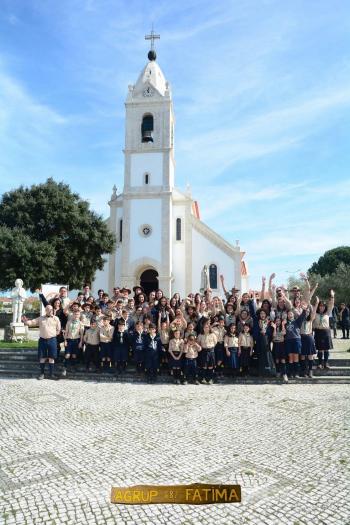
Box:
left=111, top=483, right=241, bottom=505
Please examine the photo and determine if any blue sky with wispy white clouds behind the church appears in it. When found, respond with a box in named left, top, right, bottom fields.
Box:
left=0, top=0, right=350, bottom=287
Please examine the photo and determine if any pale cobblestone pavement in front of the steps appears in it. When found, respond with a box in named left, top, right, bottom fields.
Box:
left=0, top=379, right=350, bottom=525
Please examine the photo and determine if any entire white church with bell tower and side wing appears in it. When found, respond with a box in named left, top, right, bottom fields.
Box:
left=93, top=31, right=248, bottom=297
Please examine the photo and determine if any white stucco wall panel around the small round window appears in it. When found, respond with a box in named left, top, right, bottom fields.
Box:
left=129, top=199, right=162, bottom=263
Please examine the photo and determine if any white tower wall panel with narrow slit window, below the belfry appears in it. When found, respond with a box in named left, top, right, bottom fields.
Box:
left=130, top=153, right=163, bottom=186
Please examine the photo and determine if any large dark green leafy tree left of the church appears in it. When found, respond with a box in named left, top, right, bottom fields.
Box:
left=0, top=179, right=115, bottom=290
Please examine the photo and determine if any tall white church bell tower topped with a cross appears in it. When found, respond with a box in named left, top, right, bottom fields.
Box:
left=110, top=30, right=174, bottom=295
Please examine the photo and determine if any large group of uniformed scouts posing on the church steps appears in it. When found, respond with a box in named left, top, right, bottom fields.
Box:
left=34, top=274, right=334, bottom=384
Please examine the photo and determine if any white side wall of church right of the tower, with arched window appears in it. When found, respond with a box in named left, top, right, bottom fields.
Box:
left=192, top=229, right=235, bottom=297
